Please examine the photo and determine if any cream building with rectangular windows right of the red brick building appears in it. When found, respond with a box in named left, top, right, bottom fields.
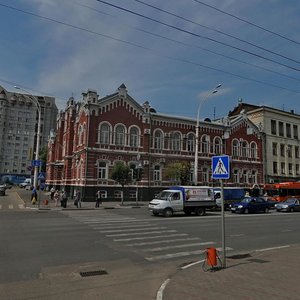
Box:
left=230, top=103, right=300, bottom=183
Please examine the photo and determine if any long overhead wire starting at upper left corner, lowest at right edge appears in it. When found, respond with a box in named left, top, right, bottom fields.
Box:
left=0, top=3, right=300, bottom=94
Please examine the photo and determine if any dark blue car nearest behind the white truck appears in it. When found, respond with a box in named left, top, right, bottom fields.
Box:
left=230, top=197, right=270, bottom=214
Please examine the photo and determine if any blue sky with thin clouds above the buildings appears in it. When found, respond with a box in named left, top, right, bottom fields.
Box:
left=0, top=0, right=300, bottom=119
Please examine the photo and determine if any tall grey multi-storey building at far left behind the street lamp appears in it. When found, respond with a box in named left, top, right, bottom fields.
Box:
left=0, top=86, right=58, bottom=176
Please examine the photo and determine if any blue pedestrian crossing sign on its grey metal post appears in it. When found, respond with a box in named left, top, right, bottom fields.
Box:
left=212, top=155, right=230, bottom=269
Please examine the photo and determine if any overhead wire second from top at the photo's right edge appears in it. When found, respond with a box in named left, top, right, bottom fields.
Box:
left=133, top=0, right=300, bottom=64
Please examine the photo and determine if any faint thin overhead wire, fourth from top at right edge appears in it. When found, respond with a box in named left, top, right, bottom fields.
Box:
left=80, top=3, right=300, bottom=81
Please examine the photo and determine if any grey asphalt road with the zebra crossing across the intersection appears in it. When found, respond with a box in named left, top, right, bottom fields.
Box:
left=0, top=191, right=300, bottom=300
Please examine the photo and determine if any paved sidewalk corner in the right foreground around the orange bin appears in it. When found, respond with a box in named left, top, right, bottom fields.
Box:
left=162, top=245, right=300, bottom=300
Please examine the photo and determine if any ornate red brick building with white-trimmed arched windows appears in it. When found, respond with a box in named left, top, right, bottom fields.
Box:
left=47, top=84, right=264, bottom=201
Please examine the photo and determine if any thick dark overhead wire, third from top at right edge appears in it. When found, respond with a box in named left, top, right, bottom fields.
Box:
left=96, top=0, right=300, bottom=72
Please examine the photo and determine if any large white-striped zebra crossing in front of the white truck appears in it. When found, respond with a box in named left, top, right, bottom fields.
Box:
left=62, top=211, right=233, bottom=262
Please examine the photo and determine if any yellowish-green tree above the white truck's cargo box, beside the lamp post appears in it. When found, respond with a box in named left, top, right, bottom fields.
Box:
left=165, top=162, right=191, bottom=185
